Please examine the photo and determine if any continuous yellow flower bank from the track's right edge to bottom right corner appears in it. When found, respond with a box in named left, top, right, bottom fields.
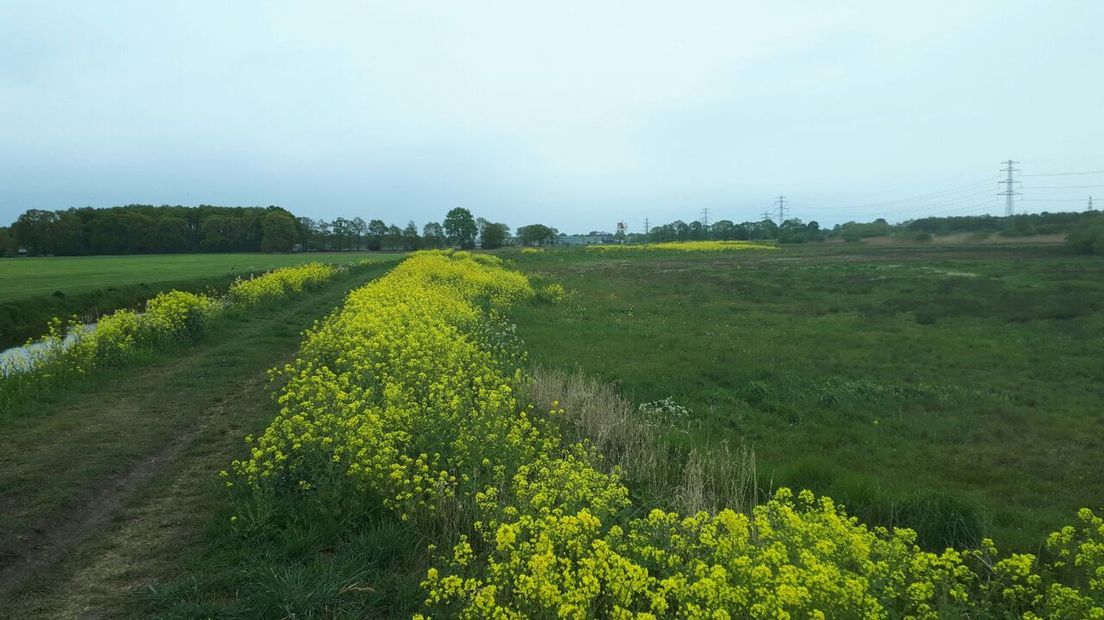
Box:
left=228, top=252, right=1104, bottom=619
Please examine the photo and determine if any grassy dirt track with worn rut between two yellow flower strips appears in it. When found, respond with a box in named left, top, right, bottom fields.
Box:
left=0, top=268, right=385, bottom=617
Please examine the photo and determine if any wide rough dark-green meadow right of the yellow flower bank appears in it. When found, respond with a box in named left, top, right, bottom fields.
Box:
left=513, top=244, right=1104, bottom=548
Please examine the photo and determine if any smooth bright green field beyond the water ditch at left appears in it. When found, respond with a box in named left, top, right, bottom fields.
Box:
left=0, top=252, right=403, bottom=349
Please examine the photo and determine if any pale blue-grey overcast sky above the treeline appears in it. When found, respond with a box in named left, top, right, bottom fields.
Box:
left=0, top=0, right=1104, bottom=232
